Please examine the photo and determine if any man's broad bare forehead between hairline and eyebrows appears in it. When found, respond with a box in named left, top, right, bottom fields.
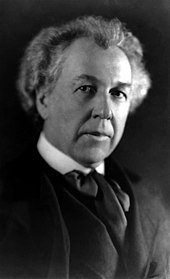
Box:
left=62, top=38, right=131, bottom=83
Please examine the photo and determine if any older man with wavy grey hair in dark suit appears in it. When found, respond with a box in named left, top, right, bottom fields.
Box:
left=0, top=17, right=169, bottom=279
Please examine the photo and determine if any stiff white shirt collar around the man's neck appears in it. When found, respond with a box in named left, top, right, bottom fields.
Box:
left=37, top=132, right=104, bottom=174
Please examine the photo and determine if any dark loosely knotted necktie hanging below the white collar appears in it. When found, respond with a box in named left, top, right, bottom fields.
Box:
left=65, top=171, right=130, bottom=251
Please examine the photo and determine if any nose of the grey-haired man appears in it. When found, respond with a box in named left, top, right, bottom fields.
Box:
left=92, top=95, right=113, bottom=120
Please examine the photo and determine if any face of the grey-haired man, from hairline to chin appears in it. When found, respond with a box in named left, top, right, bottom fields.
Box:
left=40, top=38, right=132, bottom=167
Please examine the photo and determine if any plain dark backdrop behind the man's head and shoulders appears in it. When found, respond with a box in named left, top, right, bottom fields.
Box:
left=0, top=0, right=170, bottom=209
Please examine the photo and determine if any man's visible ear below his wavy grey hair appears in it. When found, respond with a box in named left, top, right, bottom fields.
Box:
left=36, top=90, right=48, bottom=120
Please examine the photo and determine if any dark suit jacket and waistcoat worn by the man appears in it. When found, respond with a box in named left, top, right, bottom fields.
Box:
left=0, top=148, right=170, bottom=279
